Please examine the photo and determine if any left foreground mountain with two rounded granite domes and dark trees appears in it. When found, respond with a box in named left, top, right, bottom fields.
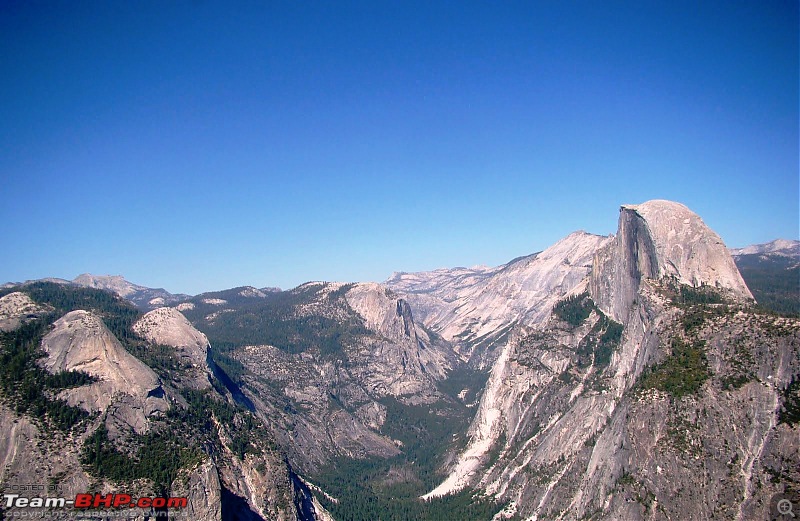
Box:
left=0, top=282, right=326, bottom=521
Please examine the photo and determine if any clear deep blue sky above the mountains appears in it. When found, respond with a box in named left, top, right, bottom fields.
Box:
left=0, top=0, right=800, bottom=293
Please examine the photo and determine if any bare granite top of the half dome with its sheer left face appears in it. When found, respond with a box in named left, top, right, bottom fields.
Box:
left=589, top=200, right=753, bottom=322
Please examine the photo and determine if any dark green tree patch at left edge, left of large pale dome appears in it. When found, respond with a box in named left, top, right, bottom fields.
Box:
left=0, top=314, right=94, bottom=432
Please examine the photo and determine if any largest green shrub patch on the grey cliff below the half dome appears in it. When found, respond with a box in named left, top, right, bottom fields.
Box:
left=640, top=337, right=711, bottom=398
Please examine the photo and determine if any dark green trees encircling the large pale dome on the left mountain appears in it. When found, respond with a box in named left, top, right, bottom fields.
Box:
left=0, top=283, right=282, bottom=494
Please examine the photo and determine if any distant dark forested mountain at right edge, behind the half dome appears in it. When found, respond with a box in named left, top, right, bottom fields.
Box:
left=731, top=239, right=800, bottom=316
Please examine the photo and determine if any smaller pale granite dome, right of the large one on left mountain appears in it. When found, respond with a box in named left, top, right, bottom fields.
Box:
left=133, top=308, right=213, bottom=389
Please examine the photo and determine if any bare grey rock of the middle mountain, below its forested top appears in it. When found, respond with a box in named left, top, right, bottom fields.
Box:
left=234, top=282, right=460, bottom=469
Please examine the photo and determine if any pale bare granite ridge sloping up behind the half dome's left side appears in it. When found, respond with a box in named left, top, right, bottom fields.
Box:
left=386, top=232, right=611, bottom=367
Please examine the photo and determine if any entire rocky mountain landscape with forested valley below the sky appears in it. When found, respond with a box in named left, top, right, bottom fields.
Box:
left=0, top=200, right=800, bottom=521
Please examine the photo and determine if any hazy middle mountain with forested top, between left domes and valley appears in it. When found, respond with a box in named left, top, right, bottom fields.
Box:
left=179, top=282, right=463, bottom=469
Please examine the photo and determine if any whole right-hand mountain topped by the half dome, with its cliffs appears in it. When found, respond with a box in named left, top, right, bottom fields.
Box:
left=416, top=201, right=800, bottom=519
